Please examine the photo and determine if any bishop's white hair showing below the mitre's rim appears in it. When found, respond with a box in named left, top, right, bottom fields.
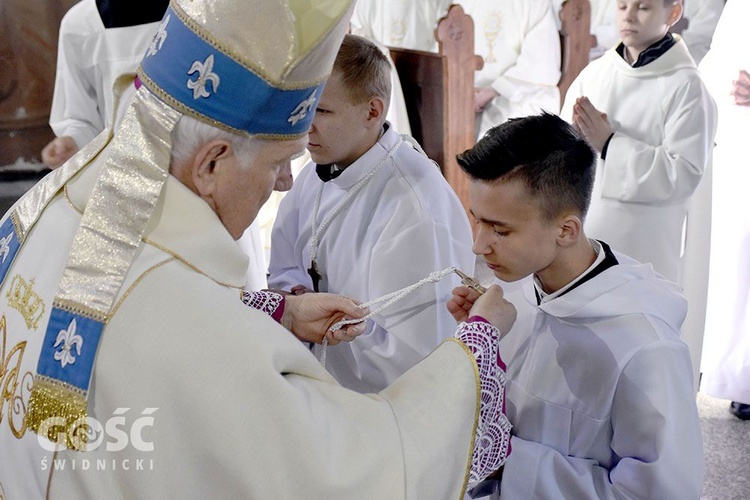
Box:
left=170, top=115, right=261, bottom=168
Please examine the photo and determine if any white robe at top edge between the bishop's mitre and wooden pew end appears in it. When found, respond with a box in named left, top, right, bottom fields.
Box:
left=351, top=0, right=452, bottom=52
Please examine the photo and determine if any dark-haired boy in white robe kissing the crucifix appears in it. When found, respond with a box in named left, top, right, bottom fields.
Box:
left=449, top=111, right=703, bottom=500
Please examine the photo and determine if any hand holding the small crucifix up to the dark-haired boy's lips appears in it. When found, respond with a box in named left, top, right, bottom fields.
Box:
left=446, top=285, right=516, bottom=339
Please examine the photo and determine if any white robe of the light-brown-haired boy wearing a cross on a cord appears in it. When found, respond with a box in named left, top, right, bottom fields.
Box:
left=268, top=128, right=475, bottom=392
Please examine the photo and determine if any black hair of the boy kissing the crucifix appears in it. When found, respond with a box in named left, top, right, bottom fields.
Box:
left=456, top=112, right=596, bottom=224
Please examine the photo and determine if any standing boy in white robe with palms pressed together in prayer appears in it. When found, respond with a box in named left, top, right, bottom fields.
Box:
left=561, top=0, right=716, bottom=381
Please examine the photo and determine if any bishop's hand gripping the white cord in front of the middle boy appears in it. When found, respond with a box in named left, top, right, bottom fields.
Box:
left=281, top=293, right=370, bottom=345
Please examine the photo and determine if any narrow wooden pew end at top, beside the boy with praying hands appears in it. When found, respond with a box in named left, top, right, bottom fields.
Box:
left=557, top=0, right=596, bottom=106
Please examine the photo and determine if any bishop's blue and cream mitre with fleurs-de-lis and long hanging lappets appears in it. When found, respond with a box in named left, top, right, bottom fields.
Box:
left=0, top=0, right=353, bottom=449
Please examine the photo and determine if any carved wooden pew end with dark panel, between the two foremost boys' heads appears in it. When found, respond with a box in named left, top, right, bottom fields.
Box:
left=389, top=5, right=483, bottom=215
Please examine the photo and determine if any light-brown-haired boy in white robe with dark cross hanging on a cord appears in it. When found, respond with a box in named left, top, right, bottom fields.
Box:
left=268, top=35, right=475, bottom=392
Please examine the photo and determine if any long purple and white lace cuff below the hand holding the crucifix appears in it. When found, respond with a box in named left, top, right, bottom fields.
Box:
left=456, top=318, right=511, bottom=489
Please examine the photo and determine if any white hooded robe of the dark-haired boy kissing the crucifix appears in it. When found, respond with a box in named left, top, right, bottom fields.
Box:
left=488, top=253, right=703, bottom=500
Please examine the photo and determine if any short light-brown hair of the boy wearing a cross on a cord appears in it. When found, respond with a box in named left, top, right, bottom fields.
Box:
left=333, top=35, right=391, bottom=107
